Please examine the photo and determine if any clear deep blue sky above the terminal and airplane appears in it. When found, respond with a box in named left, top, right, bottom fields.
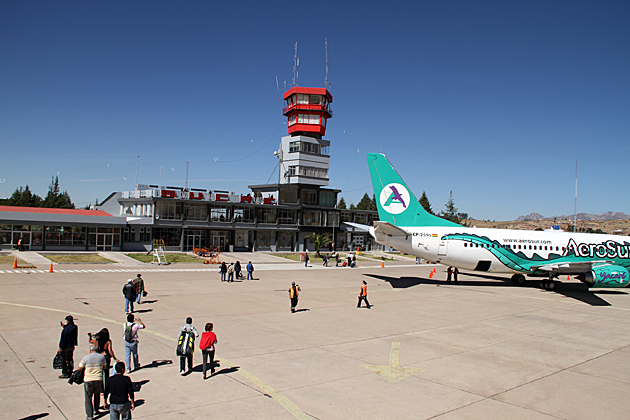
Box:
left=0, top=1, right=630, bottom=220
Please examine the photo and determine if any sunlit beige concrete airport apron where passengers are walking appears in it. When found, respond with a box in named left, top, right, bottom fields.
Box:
left=0, top=260, right=630, bottom=420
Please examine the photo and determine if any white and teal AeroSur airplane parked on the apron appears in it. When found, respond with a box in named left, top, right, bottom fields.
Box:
left=367, top=153, right=630, bottom=290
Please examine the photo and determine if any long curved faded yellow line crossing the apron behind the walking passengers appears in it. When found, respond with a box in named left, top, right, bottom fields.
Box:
left=0, top=302, right=312, bottom=420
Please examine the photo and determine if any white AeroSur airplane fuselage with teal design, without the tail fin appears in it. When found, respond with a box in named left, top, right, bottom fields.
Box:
left=370, top=226, right=630, bottom=274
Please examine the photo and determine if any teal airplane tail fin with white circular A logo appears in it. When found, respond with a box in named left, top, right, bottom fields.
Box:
left=367, top=153, right=459, bottom=226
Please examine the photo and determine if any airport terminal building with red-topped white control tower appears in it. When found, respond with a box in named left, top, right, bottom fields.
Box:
left=0, top=86, right=380, bottom=252
